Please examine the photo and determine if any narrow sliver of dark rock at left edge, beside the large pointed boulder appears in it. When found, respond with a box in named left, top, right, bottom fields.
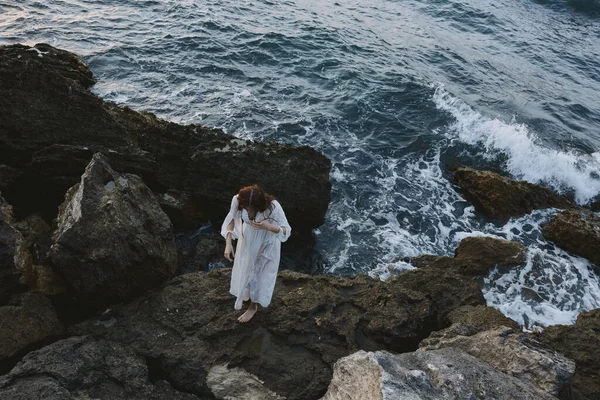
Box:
left=0, top=204, right=27, bottom=298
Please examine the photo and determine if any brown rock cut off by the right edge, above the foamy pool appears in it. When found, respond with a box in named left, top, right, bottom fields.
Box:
left=542, top=209, right=600, bottom=266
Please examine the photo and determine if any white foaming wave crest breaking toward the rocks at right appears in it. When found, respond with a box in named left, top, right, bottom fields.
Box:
left=433, top=84, right=600, bottom=204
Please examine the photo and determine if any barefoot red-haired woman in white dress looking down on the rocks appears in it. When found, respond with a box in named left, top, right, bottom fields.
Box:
left=221, top=185, right=292, bottom=322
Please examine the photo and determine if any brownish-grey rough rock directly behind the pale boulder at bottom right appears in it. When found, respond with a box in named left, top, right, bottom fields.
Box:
left=420, top=327, right=575, bottom=396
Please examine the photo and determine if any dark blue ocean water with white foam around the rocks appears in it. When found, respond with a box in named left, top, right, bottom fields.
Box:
left=0, top=0, right=600, bottom=329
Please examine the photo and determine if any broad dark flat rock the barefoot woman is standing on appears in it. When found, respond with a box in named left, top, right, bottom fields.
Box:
left=72, top=268, right=484, bottom=400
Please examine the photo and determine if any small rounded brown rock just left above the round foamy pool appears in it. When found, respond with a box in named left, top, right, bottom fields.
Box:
left=411, top=236, right=525, bottom=276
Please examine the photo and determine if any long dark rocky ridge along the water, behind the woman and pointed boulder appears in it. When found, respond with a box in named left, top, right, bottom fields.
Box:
left=0, top=44, right=331, bottom=232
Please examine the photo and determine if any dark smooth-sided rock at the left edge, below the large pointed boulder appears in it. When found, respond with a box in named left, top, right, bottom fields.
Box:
left=0, top=293, right=65, bottom=359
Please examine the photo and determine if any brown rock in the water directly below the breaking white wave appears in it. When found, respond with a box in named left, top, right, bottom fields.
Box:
left=453, top=168, right=573, bottom=220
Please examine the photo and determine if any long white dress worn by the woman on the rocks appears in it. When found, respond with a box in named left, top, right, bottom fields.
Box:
left=221, top=195, right=292, bottom=310
